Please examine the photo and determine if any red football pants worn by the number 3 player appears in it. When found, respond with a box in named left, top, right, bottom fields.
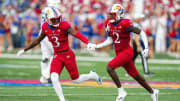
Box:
left=50, top=50, right=79, bottom=80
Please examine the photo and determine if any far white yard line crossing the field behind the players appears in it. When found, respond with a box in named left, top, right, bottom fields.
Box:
left=0, top=54, right=180, bottom=64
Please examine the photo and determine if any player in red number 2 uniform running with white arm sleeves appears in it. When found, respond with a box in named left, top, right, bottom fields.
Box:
left=88, top=4, right=159, bottom=101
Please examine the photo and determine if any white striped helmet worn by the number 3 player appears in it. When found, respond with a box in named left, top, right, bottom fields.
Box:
left=46, top=7, right=62, bottom=27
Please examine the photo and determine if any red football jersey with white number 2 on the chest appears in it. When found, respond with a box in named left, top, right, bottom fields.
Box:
left=106, top=19, right=133, bottom=52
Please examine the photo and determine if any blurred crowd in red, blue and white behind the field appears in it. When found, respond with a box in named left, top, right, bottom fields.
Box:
left=0, top=0, right=180, bottom=57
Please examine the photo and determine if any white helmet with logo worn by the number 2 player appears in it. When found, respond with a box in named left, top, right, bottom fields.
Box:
left=108, top=4, right=124, bottom=23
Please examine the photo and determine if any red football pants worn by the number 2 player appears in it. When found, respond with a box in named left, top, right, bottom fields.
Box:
left=108, top=48, right=138, bottom=77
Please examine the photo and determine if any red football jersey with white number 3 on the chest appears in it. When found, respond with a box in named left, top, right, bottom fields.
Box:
left=42, top=21, right=70, bottom=52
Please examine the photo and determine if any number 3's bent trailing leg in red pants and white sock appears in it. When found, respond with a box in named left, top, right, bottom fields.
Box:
left=65, top=50, right=102, bottom=84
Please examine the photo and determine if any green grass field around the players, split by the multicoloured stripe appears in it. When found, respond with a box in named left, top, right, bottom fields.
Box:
left=0, top=54, right=180, bottom=101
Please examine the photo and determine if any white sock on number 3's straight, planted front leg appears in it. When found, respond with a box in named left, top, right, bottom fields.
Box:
left=51, top=72, right=65, bottom=101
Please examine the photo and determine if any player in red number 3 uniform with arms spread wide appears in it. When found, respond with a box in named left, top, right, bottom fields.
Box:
left=17, top=8, right=102, bottom=101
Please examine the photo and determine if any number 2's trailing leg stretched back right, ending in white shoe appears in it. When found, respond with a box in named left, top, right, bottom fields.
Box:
left=123, top=61, right=159, bottom=101
